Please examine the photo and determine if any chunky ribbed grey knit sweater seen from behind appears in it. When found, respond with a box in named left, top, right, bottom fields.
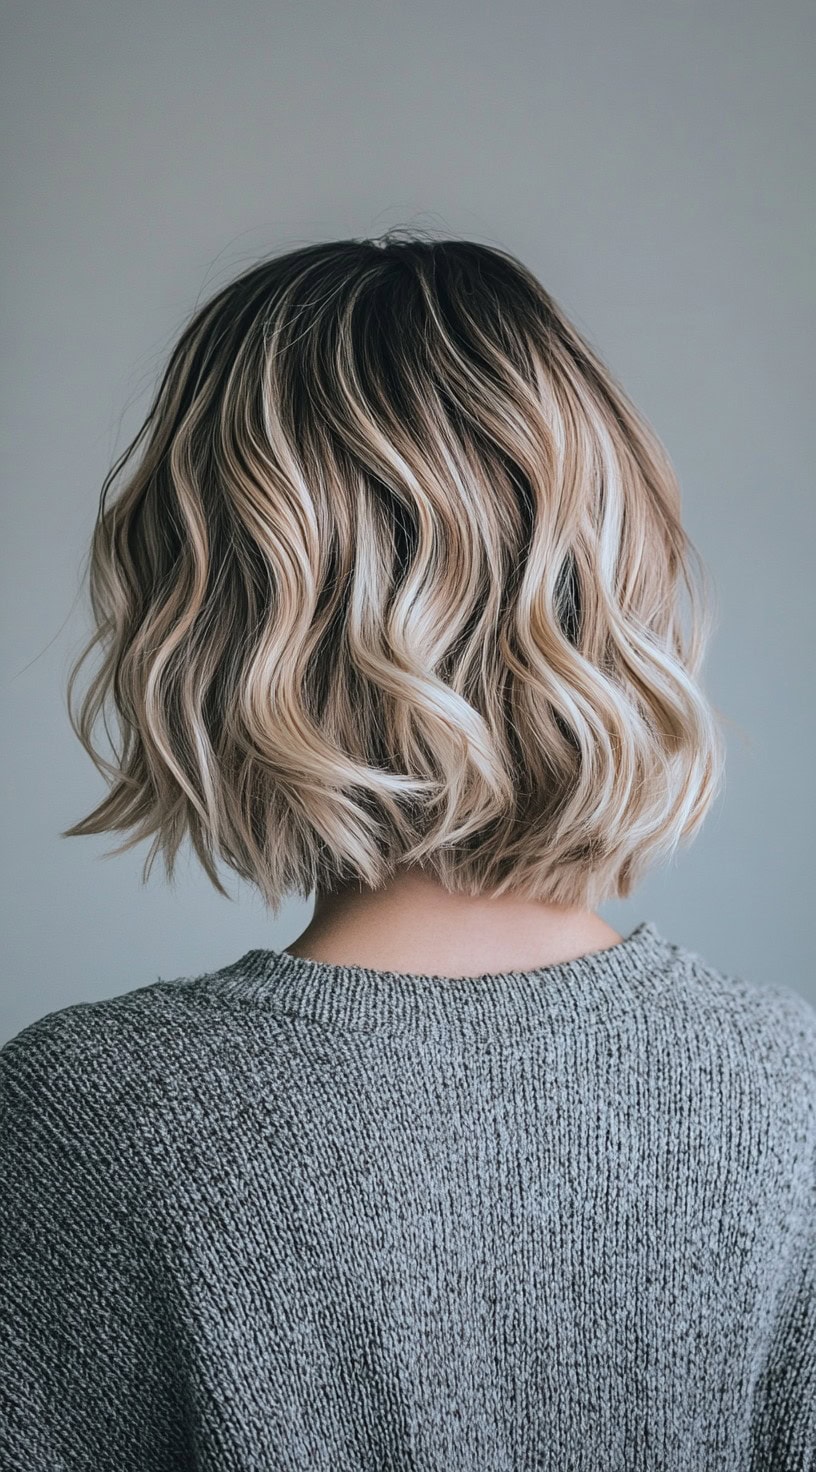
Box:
left=0, top=921, right=816, bottom=1472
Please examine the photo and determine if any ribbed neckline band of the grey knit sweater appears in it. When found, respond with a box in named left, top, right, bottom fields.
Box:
left=208, top=920, right=676, bottom=1032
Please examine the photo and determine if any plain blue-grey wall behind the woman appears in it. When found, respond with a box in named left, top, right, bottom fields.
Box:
left=0, top=0, right=816, bottom=1038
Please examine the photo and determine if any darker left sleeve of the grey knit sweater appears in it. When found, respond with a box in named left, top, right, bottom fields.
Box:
left=0, top=1004, right=190, bottom=1472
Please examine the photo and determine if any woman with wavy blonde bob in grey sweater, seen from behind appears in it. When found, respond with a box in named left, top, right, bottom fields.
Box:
left=0, top=233, right=816, bottom=1472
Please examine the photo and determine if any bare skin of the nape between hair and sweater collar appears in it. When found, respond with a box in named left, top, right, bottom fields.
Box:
left=286, top=870, right=622, bottom=976
